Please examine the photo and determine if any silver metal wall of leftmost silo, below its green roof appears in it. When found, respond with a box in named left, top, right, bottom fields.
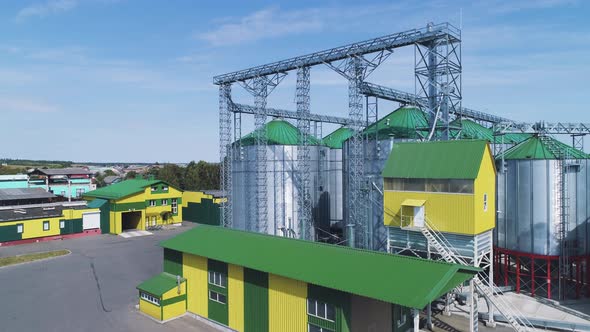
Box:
left=232, top=145, right=328, bottom=237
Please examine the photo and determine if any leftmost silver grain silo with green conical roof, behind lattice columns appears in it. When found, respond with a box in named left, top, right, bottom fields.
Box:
left=232, top=119, right=328, bottom=238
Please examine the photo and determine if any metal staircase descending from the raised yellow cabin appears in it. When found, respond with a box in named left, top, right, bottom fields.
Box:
left=420, top=218, right=535, bottom=332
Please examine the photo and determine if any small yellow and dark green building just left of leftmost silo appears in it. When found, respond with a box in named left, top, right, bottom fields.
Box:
left=182, top=190, right=225, bottom=225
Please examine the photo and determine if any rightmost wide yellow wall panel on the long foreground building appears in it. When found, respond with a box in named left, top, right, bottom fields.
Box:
left=268, top=273, right=307, bottom=332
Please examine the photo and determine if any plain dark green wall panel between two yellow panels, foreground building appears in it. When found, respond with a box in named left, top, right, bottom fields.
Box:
left=244, top=268, right=268, bottom=332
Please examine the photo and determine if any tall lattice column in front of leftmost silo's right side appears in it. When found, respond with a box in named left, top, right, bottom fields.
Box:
left=296, top=67, right=317, bottom=240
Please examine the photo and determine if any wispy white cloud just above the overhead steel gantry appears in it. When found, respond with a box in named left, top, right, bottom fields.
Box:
left=197, top=8, right=322, bottom=46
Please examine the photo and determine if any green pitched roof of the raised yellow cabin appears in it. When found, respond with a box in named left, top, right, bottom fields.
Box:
left=382, top=140, right=488, bottom=179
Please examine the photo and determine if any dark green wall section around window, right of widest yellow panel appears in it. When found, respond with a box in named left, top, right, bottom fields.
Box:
left=307, top=284, right=351, bottom=332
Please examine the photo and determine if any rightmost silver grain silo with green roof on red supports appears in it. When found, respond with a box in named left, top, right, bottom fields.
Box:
left=494, top=135, right=590, bottom=299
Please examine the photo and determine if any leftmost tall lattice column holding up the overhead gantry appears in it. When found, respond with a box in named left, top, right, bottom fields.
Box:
left=219, top=84, right=233, bottom=227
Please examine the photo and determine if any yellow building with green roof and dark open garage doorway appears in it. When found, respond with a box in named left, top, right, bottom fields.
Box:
left=84, top=179, right=182, bottom=234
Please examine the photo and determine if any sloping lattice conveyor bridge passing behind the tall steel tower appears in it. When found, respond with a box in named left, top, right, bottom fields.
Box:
left=361, top=82, right=511, bottom=123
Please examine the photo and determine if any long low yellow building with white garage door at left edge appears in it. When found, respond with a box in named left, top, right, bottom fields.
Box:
left=0, top=188, right=100, bottom=246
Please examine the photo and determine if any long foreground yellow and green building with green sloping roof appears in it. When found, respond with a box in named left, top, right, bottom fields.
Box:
left=137, top=225, right=479, bottom=332
